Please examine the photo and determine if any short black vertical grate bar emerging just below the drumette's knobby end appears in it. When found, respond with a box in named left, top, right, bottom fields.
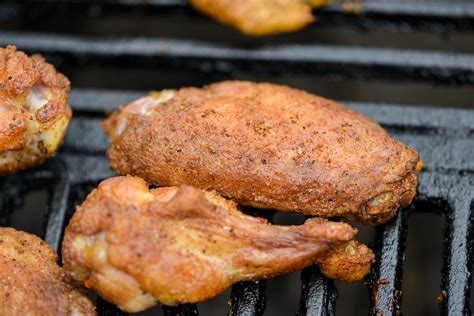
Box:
left=297, top=265, right=337, bottom=316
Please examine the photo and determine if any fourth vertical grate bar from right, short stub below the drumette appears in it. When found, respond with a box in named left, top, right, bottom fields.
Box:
left=229, top=281, right=266, bottom=316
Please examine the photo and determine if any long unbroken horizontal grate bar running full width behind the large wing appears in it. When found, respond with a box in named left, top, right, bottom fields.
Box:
left=0, top=32, right=474, bottom=84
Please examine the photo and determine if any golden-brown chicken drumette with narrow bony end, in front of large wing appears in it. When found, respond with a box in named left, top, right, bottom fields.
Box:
left=62, top=177, right=374, bottom=312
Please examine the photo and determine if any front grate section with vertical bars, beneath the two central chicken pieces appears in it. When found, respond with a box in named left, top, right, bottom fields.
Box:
left=0, top=89, right=474, bottom=315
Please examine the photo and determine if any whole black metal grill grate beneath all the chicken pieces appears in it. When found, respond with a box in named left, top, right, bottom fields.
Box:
left=0, top=0, right=474, bottom=315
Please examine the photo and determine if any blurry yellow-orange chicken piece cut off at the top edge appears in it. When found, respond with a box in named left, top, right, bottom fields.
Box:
left=191, top=0, right=332, bottom=36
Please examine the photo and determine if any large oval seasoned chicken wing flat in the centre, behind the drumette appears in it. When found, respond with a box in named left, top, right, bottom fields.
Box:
left=103, top=81, right=421, bottom=224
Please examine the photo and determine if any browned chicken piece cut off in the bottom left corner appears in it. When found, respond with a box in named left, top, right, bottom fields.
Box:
left=0, top=227, right=96, bottom=316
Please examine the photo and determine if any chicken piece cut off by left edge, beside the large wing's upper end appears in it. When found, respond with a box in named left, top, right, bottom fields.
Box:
left=0, top=46, right=71, bottom=175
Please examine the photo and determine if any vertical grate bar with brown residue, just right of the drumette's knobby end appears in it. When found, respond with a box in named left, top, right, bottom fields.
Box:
left=369, top=205, right=407, bottom=315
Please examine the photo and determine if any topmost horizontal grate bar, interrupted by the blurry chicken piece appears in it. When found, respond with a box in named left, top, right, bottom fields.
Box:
left=0, top=0, right=474, bottom=32
